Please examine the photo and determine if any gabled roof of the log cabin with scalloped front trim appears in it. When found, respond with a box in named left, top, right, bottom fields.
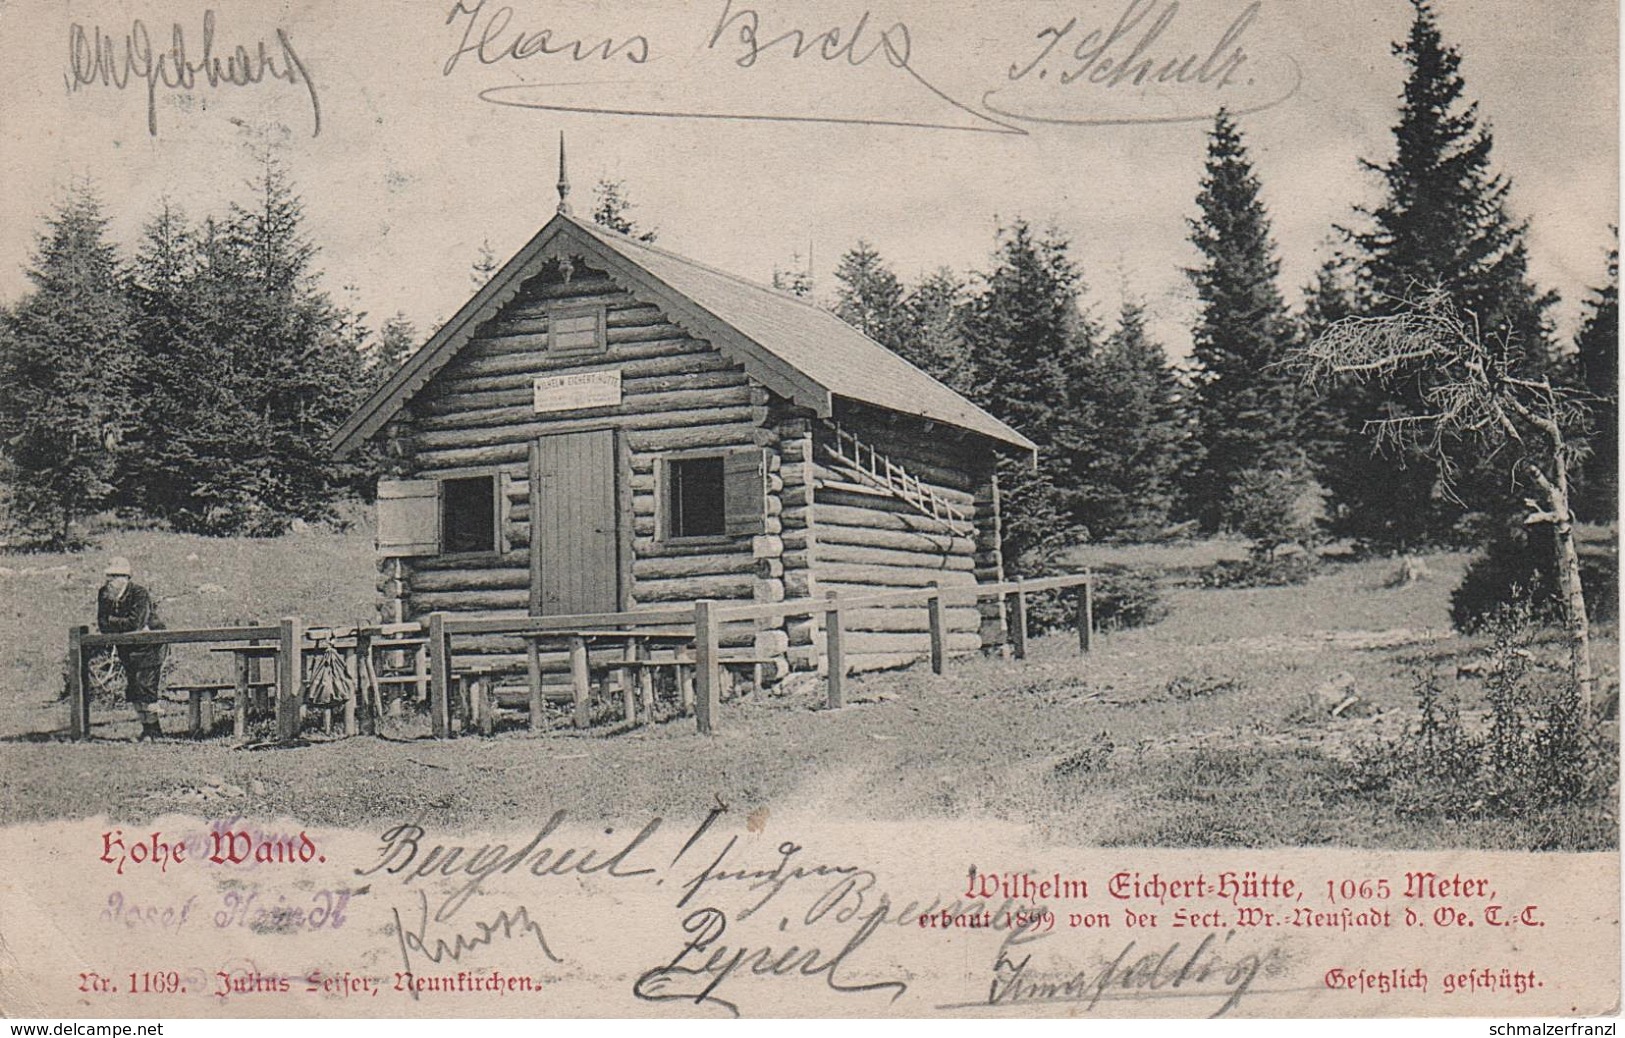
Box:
left=330, top=213, right=1037, bottom=455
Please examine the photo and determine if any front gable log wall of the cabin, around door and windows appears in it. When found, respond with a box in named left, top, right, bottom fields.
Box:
left=396, top=266, right=770, bottom=656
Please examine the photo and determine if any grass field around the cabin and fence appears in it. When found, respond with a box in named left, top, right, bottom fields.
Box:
left=0, top=516, right=1619, bottom=848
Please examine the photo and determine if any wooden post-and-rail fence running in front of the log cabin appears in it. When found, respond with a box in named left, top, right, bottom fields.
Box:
left=68, top=572, right=1095, bottom=741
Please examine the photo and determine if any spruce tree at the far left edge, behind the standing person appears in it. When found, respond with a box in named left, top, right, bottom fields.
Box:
left=0, top=187, right=133, bottom=547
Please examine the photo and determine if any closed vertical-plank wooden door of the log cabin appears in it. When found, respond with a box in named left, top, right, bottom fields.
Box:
left=530, top=429, right=617, bottom=616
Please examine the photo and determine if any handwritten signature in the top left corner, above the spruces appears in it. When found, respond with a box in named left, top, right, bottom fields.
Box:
left=63, top=10, right=322, bottom=136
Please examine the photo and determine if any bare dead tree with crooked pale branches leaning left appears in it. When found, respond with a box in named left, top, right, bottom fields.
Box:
left=1294, top=291, right=1596, bottom=710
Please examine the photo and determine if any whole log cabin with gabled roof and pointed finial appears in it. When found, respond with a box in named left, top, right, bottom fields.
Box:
left=330, top=141, right=1035, bottom=677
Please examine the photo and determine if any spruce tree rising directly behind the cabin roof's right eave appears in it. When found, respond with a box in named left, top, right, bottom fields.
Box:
left=962, top=219, right=1081, bottom=575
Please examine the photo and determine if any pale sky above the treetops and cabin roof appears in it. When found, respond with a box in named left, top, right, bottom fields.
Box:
left=0, top=0, right=1620, bottom=356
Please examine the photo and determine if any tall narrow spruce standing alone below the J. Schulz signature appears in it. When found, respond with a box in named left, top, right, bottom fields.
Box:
left=1186, top=110, right=1297, bottom=530
